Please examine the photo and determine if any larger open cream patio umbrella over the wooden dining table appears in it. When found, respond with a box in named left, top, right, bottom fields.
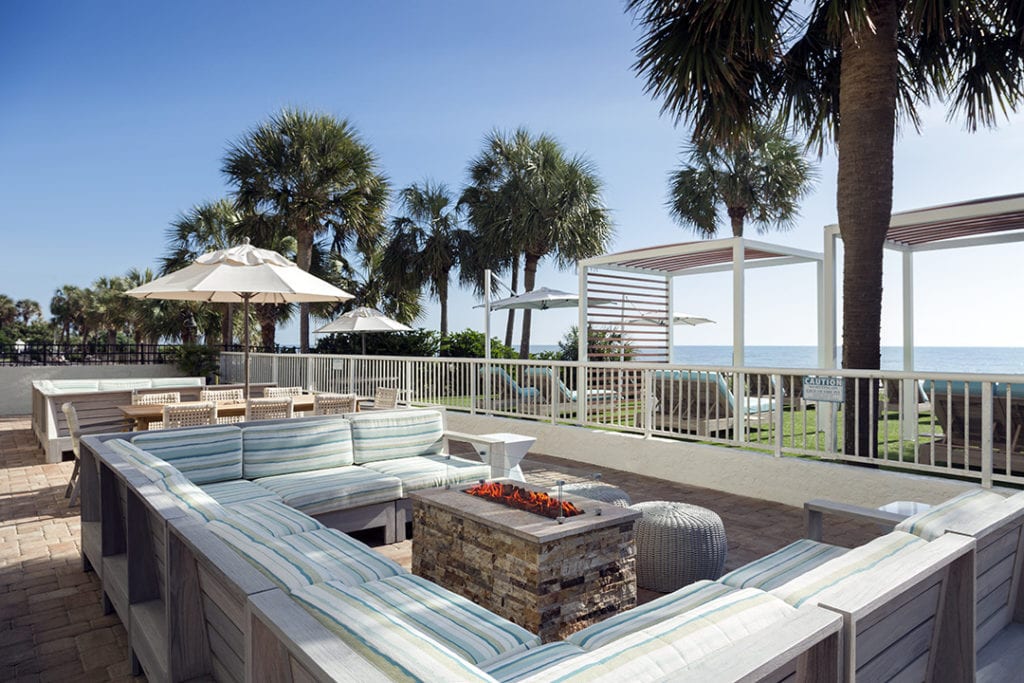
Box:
left=126, top=238, right=352, bottom=396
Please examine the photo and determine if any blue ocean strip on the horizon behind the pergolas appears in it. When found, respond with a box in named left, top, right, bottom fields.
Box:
left=531, top=345, right=1024, bottom=375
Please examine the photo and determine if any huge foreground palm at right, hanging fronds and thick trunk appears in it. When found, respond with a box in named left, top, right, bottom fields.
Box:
left=627, top=0, right=1024, bottom=453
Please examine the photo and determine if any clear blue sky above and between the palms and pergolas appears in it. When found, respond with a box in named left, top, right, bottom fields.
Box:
left=0, top=0, right=1024, bottom=346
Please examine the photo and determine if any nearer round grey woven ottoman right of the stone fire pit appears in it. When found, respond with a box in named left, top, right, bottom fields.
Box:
left=630, top=501, right=727, bottom=593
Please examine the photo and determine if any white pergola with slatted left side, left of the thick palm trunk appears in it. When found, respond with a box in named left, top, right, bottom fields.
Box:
left=579, top=238, right=835, bottom=367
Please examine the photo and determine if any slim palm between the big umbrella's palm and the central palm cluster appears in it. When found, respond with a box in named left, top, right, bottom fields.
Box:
left=382, top=180, right=472, bottom=339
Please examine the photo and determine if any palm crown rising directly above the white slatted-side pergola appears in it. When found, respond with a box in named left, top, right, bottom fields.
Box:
left=669, top=124, right=814, bottom=238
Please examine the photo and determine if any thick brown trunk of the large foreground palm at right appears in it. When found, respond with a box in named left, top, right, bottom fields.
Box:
left=837, top=0, right=899, bottom=457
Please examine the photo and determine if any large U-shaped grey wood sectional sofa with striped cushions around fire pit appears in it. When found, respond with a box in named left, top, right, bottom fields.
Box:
left=82, top=411, right=991, bottom=683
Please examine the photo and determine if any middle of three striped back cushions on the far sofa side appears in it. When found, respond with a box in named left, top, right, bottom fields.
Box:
left=242, top=420, right=352, bottom=479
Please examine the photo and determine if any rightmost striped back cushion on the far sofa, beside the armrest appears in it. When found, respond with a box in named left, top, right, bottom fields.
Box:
left=350, top=411, right=444, bottom=465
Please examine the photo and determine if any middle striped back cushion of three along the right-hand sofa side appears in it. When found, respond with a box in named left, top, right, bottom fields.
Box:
left=771, top=531, right=928, bottom=607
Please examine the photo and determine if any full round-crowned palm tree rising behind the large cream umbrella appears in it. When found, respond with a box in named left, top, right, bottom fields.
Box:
left=222, top=110, right=388, bottom=352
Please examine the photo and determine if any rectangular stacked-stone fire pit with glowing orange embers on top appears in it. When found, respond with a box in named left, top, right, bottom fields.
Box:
left=410, top=482, right=640, bottom=642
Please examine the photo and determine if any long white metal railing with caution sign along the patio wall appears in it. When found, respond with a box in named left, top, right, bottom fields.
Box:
left=220, top=352, right=1024, bottom=486
